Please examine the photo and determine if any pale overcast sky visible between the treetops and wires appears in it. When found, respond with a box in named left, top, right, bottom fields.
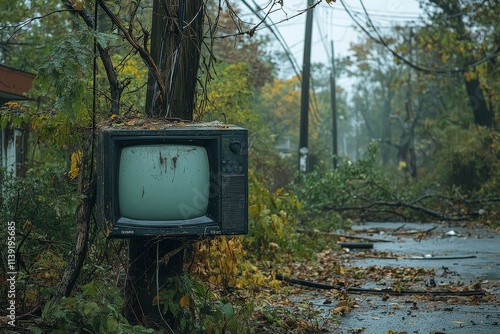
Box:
left=247, top=0, right=421, bottom=77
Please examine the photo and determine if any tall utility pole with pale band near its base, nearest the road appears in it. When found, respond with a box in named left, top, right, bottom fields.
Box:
left=299, top=0, right=314, bottom=173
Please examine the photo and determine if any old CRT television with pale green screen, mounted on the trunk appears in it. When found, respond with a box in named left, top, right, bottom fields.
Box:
left=97, top=123, right=248, bottom=238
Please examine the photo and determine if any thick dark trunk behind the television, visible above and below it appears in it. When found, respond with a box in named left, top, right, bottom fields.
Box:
left=125, top=0, right=205, bottom=327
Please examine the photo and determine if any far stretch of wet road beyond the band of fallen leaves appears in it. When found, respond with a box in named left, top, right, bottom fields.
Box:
left=352, top=223, right=500, bottom=281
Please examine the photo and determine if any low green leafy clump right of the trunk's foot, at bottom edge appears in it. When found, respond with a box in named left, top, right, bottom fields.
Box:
left=158, top=275, right=253, bottom=334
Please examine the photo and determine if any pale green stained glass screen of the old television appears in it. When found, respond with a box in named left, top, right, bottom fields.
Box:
left=118, top=144, right=210, bottom=222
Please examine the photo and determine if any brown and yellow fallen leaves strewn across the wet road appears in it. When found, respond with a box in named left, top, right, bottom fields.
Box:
left=250, top=223, right=500, bottom=333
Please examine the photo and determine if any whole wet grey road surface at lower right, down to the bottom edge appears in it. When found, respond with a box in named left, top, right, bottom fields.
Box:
left=288, top=223, right=500, bottom=334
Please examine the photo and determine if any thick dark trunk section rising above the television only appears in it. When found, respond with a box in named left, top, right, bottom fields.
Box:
left=146, top=0, right=205, bottom=120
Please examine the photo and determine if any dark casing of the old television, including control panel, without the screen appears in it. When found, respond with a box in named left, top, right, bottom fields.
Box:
left=97, top=123, right=248, bottom=238
